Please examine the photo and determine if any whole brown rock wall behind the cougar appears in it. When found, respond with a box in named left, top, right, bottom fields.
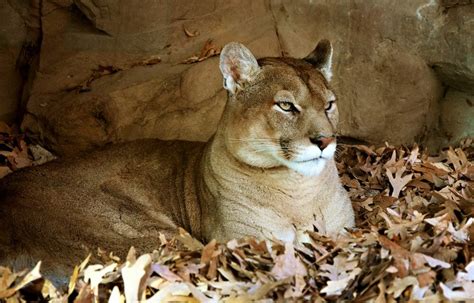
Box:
left=0, top=0, right=474, bottom=154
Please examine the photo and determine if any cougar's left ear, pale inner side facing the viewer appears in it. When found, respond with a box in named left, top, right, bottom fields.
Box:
left=219, top=42, right=260, bottom=94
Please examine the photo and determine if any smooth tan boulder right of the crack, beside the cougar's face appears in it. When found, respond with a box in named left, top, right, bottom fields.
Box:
left=273, top=0, right=474, bottom=147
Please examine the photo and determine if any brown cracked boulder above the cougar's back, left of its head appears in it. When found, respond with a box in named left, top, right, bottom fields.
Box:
left=23, top=0, right=280, bottom=154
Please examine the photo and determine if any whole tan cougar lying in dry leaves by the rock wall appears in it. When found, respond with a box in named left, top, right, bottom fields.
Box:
left=0, top=40, right=354, bottom=274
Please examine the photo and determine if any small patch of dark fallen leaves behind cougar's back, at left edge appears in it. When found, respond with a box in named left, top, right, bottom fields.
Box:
left=0, top=121, right=55, bottom=178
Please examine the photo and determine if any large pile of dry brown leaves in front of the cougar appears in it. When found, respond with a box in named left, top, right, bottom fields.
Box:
left=0, top=140, right=474, bottom=302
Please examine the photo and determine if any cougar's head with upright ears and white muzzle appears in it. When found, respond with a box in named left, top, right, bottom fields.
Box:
left=220, top=40, right=338, bottom=176
